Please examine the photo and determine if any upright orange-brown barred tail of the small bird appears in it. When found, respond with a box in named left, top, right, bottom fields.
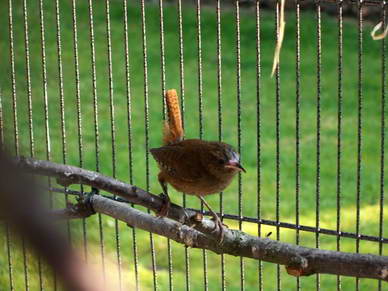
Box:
left=163, top=89, right=184, bottom=145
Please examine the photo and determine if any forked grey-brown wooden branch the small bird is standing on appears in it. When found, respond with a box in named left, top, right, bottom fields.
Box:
left=18, top=158, right=388, bottom=281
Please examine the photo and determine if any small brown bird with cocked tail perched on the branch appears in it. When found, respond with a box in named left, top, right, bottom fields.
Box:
left=150, top=89, right=245, bottom=241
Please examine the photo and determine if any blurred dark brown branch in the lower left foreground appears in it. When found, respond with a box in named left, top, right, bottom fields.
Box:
left=0, top=150, right=113, bottom=291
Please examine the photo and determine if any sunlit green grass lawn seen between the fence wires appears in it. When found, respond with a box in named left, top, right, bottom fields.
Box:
left=0, top=1, right=388, bottom=290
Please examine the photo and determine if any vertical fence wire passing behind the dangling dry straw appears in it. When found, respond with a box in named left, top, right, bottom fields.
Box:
left=275, top=0, right=281, bottom=290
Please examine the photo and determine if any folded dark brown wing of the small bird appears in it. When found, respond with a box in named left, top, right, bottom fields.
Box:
left=150, top=145, right=202, bottom=182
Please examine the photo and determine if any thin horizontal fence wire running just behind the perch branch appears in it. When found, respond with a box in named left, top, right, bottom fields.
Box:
left=42, top=187, right=388, bottom=244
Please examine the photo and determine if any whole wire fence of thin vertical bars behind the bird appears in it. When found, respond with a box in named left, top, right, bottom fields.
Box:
left=0, top=0, right=388, bottom=290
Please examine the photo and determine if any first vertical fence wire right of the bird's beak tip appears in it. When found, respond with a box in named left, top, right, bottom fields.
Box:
left=256, top=0, right=263, bottom=291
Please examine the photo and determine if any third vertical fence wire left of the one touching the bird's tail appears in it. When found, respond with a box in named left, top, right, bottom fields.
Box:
left=105, top=0, right=122, bottom=290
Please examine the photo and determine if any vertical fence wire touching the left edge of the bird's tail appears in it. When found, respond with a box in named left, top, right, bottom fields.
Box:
left=159, top=0, right=173, bottom=291
